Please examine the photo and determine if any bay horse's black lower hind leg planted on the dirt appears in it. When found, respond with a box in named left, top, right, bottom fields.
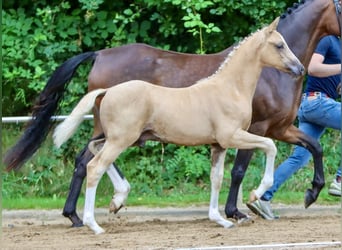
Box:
left=63, top=145, right=94, bottom=227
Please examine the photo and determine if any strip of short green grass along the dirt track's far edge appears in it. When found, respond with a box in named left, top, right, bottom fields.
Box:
left=2, top=189, right=341, bottom=210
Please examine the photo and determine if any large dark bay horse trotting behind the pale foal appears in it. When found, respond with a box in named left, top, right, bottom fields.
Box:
left=4, top=0, right=341, bottom=226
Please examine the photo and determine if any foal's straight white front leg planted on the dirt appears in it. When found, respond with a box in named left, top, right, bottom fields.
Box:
left=209, top=146, right=234, bottom=228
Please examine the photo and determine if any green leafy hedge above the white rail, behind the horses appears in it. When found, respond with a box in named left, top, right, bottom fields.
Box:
left=2, top=0, right=293, bottom=115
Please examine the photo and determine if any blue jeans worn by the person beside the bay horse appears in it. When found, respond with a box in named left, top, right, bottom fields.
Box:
left=261, top=94, right=342, bottom=201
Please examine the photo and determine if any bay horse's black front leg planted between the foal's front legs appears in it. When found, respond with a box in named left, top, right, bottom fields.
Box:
left=225, top=149, right=254, bottom=221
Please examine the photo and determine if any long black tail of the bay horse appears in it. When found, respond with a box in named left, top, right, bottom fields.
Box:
left=4, top=52, right=96, bottom=171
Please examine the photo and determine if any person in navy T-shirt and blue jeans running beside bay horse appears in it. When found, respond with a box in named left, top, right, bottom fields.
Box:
left=247, top=36, right=342, bottom=220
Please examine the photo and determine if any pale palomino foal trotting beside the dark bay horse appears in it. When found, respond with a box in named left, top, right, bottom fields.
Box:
left=54, top=20, right=304, bottom=234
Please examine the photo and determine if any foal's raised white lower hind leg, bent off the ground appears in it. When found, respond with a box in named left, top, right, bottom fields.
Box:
left=107, top=164, right=131, bottom=213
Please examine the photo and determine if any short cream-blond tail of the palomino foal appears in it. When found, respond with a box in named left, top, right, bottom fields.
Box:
left=53, top=89, right=107, bottom=148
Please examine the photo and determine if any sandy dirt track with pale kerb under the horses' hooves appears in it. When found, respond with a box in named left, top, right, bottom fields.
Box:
left=1, top=205, right=342, bottom=250
